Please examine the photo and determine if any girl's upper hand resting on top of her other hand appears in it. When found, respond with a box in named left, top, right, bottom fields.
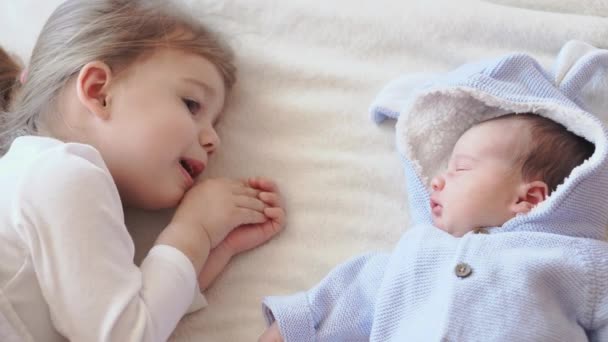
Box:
left=171, top=178, right=267, bottom=248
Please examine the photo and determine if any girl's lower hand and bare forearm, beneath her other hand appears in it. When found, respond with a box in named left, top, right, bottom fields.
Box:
left=198, top=178, right=285, bottom=291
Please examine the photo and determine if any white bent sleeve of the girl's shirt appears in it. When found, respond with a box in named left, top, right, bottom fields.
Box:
left=16, top=144, right=196, bottom=341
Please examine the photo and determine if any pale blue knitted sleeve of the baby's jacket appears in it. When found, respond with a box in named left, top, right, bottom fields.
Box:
left=263, top=254, right=389, bottom=342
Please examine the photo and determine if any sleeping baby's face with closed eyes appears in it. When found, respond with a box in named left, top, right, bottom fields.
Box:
left=430, top=120, right=529, bottom=236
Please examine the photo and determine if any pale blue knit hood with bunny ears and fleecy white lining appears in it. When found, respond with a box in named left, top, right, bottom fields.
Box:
left=370, top=41, right=608, bottom=239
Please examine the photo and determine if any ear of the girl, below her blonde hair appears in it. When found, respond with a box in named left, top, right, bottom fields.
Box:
left=76, top=61, right=112, bottom=120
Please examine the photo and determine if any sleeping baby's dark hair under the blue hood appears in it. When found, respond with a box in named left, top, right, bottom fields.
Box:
left=492, top=113, right=595, bottom=193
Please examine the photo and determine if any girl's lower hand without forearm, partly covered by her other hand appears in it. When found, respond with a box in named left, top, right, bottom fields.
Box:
left=222, top=177, right=285, bottom=255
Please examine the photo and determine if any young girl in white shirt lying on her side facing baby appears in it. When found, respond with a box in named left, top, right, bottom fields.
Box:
left=0, top=0, right=285, bottom=341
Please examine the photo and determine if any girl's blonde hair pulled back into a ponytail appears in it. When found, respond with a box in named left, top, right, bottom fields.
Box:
left=0, top=0, right=236, bottom=156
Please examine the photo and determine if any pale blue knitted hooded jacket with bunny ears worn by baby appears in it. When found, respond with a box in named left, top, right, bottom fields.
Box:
left=264, top=41, right=608, bottom=342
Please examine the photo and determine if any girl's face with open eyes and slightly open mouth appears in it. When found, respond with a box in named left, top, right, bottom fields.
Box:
left=97, top=49, right=226, bottom=209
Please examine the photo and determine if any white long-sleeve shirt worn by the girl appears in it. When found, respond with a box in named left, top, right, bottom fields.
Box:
left=0, top=137, right=200, bottom=342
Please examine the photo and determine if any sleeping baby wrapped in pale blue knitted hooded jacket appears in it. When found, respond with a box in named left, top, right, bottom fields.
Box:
left=260, top=40, right=608, bottom=342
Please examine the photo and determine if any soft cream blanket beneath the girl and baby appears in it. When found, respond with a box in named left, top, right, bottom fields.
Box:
left=0, top=0, right=608, bottom=341
